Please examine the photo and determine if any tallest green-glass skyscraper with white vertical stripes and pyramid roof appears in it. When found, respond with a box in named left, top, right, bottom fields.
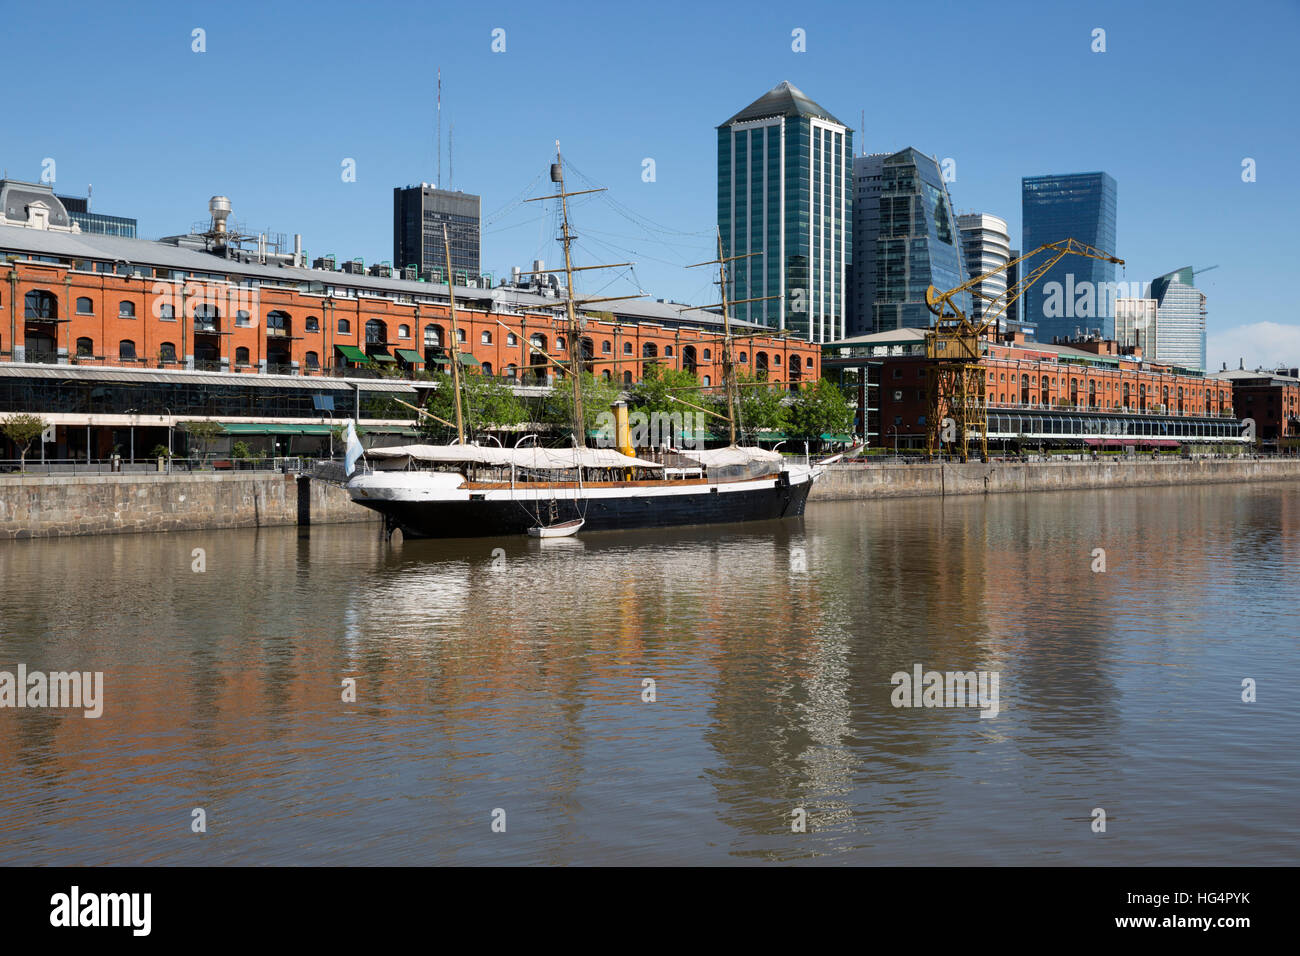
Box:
left=718, top=82, right=853, bottom=342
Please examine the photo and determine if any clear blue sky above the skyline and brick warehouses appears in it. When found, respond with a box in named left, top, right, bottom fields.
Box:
left=0, top=0, right=1300, bottom=368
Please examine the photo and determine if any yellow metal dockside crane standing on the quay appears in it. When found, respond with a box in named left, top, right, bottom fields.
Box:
left=926, top=239, right=1125, bottom=462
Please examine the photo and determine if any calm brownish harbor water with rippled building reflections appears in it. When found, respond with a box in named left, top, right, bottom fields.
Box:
left=0, top=484, right=1300, bottom=865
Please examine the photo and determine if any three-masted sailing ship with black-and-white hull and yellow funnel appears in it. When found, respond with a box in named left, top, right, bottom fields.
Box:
left=346, top=143, right=822, bottom=538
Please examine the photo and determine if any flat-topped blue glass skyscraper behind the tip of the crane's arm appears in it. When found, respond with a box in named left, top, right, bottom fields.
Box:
left=1021, top=173, right=1121, bottom=342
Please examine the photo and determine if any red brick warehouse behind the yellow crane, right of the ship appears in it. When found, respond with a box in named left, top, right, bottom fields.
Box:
left=823, top=329, right=1240, bottom=449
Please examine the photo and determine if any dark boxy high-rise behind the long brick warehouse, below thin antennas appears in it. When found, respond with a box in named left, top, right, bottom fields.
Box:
left=393, top=182, right=482, bottom=285
